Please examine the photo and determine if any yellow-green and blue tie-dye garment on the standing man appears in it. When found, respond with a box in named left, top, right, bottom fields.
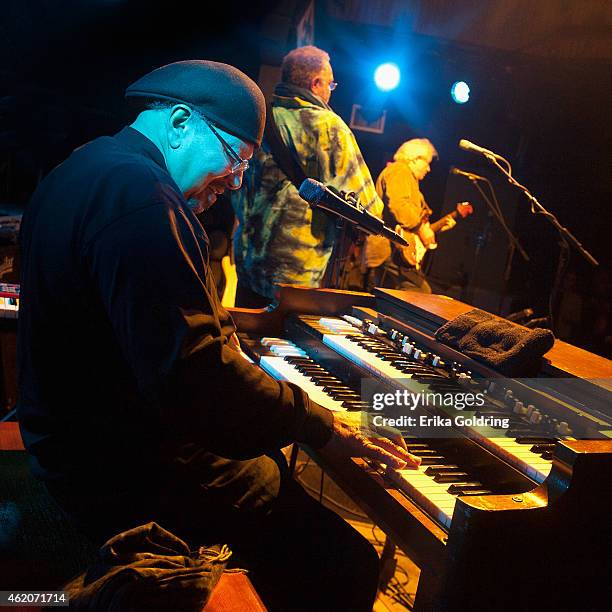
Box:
left=232, top=90, right=383, bottom=298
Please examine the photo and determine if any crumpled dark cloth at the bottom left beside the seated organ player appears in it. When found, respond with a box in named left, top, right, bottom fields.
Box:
left=64, top=523, right=231, bottom=612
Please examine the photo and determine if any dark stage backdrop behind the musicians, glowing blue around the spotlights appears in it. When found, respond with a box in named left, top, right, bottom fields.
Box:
left=0, top=0, right=612, bottom=354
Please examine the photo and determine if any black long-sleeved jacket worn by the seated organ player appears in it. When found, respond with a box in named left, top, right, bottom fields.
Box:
left=18, top=128, right=332, bottom=485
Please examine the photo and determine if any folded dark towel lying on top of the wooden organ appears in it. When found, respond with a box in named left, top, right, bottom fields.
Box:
left=436, top=308, right=555, bottom=376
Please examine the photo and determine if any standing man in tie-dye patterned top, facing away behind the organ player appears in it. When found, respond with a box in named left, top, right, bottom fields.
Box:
left=232, top=46, right=382, bottom=308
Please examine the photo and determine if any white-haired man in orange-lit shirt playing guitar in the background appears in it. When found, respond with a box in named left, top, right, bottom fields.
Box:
left=365, top=138, right=456, bottom=293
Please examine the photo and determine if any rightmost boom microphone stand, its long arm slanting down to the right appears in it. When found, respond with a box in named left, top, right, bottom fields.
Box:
left=483, top=153, right=599, bottom=331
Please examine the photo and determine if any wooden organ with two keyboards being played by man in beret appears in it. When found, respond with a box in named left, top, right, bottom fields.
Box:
left=232, top=287, right=612, bottom=610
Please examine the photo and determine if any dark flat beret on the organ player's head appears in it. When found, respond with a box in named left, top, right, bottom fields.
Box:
left=125, top=60, right=266, bottom=146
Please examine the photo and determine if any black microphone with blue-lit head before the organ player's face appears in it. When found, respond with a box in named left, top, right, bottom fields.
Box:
left=299, top=179, right=408, bottom=246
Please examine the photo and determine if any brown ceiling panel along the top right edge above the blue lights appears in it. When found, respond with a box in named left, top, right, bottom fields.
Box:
left=325, top=0, right=612, bottom=59
